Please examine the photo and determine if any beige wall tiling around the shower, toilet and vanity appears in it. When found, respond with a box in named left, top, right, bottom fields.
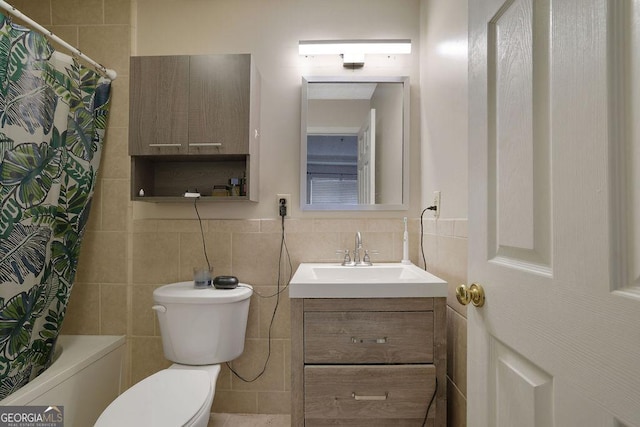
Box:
left=14, top=0, right=466, bottom=418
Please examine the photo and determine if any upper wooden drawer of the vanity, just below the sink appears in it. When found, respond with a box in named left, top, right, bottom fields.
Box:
left=304, top=311, right=433, bottom=364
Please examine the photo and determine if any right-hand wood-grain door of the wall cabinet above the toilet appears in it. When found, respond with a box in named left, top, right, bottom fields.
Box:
left=189, top=54, right=251, bottom=154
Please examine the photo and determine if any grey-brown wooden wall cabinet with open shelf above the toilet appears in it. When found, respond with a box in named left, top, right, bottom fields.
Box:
left=129, top=54, right=260, bottom=202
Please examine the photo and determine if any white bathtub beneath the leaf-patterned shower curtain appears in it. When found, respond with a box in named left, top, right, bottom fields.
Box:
left=0, top=335, right=125, bottom=427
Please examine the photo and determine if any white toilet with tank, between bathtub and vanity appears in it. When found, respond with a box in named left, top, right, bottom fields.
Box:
left=95, top=282, right=253, bottom=427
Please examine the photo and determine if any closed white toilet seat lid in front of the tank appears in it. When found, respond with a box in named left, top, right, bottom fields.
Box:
left=95, top=369, right=215, bottom=427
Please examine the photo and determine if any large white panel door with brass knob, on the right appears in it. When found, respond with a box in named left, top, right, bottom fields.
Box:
left=467, top=0, right=640, bottom=427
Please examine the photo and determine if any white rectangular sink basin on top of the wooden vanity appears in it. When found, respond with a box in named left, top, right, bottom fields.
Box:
left=289, top=263, right=447, bottom=298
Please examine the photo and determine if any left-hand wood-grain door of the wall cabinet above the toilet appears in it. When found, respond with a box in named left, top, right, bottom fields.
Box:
left=129, top=56, right=189, bottom=155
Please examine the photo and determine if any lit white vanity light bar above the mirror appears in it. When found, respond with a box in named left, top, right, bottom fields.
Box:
left=298, top=39, right=411, bottom=55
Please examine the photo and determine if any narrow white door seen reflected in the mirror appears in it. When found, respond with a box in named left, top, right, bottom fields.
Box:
left=358, top=108, right=376, bottom=205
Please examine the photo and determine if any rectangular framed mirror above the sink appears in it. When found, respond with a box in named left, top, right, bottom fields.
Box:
left=300, top=76, right=409, bottom=210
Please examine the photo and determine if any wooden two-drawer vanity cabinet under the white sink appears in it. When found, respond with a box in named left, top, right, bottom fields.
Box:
left=291, top=298, right=446, bottom=427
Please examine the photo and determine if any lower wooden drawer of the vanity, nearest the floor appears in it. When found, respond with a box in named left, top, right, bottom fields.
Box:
left=304, top=365, right=436, bottom=427
